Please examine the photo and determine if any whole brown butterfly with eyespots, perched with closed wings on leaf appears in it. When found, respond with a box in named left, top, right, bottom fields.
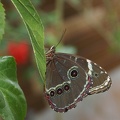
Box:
left=45, top=46, right=112, bottom=113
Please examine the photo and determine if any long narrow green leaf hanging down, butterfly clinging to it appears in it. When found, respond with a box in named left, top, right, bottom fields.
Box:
left=11, top=0, right=46, bottom=83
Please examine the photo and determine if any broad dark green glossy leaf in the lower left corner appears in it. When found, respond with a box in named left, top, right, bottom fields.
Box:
left=0, top=56, right=27, bottom=120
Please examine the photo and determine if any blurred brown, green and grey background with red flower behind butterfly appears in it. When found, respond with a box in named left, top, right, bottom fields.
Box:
left=0, top=0, right=120, bottom=120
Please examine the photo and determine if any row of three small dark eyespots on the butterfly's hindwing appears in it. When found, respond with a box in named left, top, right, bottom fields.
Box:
left=50, top=84, right=70, bottom=97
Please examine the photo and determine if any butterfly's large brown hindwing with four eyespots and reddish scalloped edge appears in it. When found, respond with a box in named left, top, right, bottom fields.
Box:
left=45, top=54, right=92, bottom=112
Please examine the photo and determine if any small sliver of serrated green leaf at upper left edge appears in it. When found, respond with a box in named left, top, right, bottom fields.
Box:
left=0, top=2, right=5, bottom=41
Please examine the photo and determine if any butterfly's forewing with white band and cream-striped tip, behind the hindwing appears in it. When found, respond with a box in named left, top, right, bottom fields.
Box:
left=59, top=53, right=112, bottom=95
